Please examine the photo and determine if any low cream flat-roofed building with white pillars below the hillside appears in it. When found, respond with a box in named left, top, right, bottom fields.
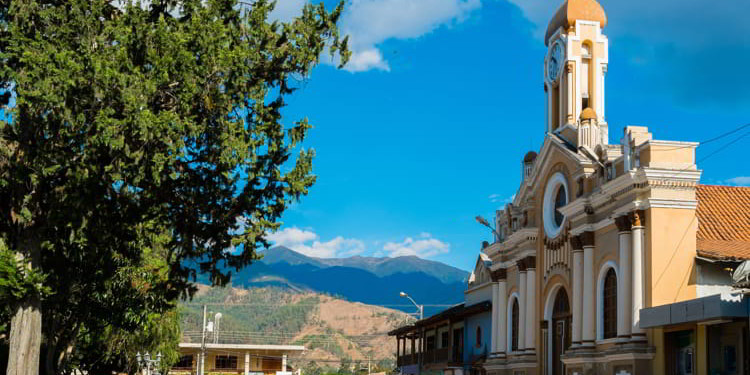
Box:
left=169, top=343, right=305, bottom=375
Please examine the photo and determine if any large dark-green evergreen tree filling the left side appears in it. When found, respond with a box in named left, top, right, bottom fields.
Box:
left=0, top=0, right=349, bottom=375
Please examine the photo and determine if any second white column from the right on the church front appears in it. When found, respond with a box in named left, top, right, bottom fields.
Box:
left=617, top=222, right=633, bottom=341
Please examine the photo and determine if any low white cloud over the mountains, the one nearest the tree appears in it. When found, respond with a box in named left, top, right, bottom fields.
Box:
left=266, top=227, right=365, bottom=258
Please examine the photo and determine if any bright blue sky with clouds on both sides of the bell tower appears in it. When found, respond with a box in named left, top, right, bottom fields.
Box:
left=264, top=0, right=750, bottom=270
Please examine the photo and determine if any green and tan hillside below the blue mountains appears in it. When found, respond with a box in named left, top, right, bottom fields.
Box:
left=180, top=286, right=412, bottom=369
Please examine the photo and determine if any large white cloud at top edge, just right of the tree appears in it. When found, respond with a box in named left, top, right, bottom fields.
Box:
left=341, top=0, right=481, bottom=72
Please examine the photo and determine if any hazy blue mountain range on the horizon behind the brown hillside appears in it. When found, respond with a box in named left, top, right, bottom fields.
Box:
left=222, top=246, right=469, bottom=316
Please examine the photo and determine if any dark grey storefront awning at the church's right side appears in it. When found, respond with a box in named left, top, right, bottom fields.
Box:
left=640, top=293, right=750, bottom=328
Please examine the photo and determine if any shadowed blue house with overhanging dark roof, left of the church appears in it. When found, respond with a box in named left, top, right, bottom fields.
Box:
left=388, top=254, right=493, bottom=375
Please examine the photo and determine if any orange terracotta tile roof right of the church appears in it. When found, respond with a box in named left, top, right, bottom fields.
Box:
left=696, top=185, right=750, bottom=260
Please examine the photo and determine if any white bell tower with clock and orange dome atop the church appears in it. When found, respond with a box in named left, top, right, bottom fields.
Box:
left=544, top=0, right=609, bottom=150
